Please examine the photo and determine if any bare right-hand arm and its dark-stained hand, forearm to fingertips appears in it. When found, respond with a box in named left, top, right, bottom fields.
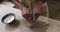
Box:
left=33, top=1, right=42, bottom=21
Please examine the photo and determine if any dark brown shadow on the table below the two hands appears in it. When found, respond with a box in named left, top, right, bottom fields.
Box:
left=31, top=22, right=49, bottom=32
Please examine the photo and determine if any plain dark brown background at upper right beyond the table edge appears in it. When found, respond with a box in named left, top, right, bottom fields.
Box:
left=47, top=0, right=60, bottom=20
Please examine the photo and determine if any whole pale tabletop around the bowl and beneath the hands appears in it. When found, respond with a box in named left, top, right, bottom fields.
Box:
left=0, top=1, right=60, bottom=32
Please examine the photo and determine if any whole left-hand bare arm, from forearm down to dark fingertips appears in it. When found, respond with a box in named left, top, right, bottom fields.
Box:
left=12, top=0, right=31, bottom=21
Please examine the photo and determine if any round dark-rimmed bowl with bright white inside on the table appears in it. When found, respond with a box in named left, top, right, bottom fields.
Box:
left=1, top=13, right=15, bottom=24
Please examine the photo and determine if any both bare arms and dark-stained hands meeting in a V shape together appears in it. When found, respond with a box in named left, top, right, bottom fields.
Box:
left=12, top=0, right=42, bottom=21
